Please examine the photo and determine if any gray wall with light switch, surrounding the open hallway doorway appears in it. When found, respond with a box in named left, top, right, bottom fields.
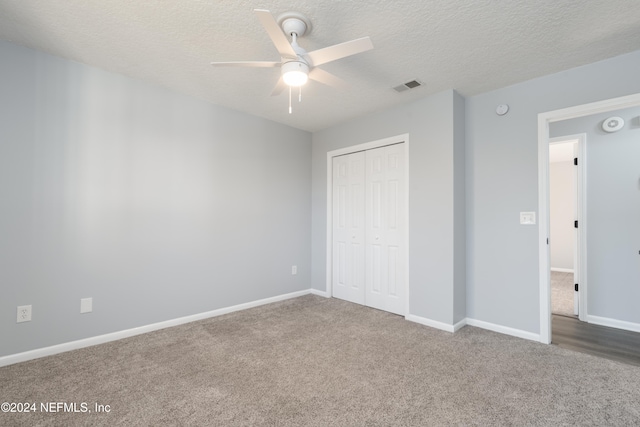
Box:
left=466, top=52, right=640, bottom=333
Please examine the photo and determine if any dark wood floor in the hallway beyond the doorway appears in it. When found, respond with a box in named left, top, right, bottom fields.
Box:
left=551, top=314, right=640, bottom=366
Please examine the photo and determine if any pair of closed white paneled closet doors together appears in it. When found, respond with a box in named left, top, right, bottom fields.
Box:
left=332, top=144, right=406, bottom=314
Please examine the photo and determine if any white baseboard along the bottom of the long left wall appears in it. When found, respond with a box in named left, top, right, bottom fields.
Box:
left=0, top=289, right=317, bottom=367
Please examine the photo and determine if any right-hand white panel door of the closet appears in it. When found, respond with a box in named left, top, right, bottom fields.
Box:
left=365, top=144, right=406, bottom=314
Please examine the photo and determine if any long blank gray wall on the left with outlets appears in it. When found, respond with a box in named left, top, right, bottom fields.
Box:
left=0, top=42, right=311, bottom=356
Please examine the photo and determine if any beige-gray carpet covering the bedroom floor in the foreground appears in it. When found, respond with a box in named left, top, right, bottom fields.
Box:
left=0, top=295, right=640, bottom=426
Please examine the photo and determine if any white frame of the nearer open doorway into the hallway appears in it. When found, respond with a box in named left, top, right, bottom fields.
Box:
left=538, top=93, right=640, bottom=344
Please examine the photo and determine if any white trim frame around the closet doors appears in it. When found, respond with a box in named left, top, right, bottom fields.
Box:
left=325, top=133, right=409, bottom=316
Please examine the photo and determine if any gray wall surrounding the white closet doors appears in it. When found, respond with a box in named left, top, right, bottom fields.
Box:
left=312, top=91, right=465, bottom=325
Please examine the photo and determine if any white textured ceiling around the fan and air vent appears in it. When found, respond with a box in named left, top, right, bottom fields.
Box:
left=0, top=0, right=640, bottom=131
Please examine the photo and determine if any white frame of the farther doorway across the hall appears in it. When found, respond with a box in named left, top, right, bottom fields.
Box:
left=547, top=133, right=587, bottom=321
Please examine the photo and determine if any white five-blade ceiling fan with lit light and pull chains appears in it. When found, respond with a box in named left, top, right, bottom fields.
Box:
left=211, top=9, right=373, bottom=113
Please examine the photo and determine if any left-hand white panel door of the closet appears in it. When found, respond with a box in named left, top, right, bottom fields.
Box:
left=332, top=152, right=365, bottom=305
